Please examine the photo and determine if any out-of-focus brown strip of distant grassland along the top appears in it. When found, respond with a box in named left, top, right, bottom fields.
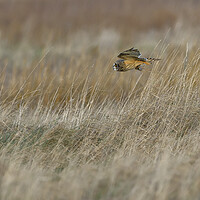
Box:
left=0, top=0, right=200, bottom=45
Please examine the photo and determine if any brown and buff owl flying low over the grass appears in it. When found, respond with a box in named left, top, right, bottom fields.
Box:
left=113, top=47, right=160, bottom=72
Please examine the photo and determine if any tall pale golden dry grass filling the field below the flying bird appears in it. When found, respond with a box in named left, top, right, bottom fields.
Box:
left=0, top=38, right=200, bottom=200
